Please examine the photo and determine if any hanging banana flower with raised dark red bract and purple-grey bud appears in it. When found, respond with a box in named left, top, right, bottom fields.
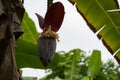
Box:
left=36, top=2, right=65, bottom=67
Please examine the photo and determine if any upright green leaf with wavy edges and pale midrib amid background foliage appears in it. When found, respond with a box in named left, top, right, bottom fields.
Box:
left=64, top=49, right=82, bottom=80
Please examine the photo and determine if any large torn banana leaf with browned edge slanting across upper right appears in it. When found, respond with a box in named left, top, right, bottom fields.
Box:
left=69, top=0, right=120, bottom=63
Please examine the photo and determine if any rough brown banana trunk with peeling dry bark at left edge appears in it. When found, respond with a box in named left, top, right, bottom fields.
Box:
left=0, top=0, right=24, bottom=80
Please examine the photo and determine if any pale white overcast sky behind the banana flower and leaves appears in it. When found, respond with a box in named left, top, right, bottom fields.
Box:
left=23, top=0, right=119, bottom=79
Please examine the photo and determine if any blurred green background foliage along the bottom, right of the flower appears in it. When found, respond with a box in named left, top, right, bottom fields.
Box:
left=40, top=49, right=120, bottom=80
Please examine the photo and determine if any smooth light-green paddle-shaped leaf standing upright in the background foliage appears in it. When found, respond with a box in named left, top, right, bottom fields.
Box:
left=87, top=50, right=102, bottom=78
